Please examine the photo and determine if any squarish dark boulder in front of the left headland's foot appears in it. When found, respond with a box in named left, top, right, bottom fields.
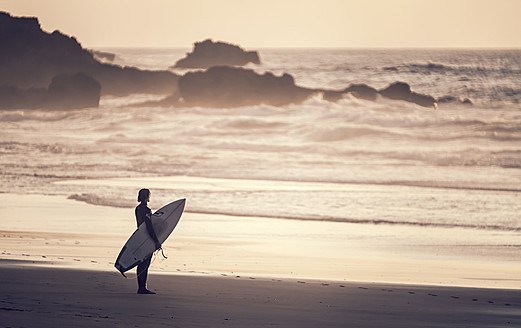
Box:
left=47, top=73, right=101, bottom=109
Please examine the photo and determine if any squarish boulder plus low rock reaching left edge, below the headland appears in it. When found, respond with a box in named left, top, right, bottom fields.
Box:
left=0, top=73, right=101, bottom=109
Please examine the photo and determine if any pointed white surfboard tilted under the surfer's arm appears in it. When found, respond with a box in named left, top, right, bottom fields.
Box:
left=114, top=199, right=186, bottom=277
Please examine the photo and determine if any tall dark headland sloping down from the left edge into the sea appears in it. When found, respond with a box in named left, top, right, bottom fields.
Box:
left=0, top=12, right=178, bottom=95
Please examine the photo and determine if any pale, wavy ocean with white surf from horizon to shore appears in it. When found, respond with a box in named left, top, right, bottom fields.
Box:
left=0, top=48, right=521, bottom=236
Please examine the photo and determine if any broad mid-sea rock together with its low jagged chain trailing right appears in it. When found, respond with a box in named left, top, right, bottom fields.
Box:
left=137, top=66, right=437, bottom=108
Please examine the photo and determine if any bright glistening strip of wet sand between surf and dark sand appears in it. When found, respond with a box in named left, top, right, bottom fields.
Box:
left=0, top=194, right=521, bottom=289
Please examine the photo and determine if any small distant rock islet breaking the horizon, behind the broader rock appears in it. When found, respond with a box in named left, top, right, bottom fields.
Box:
left=173, top=39, right=260, bottom=68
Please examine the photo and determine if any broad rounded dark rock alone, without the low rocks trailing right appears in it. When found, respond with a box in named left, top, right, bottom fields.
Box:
left=175, top=66, right=316, bottom=107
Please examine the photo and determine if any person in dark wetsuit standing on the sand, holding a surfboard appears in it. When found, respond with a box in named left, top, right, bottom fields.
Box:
left=135, top=189, right=161, bottom=294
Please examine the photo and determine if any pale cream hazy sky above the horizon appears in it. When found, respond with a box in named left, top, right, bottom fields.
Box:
left=0, top=0, right=521, bottom=48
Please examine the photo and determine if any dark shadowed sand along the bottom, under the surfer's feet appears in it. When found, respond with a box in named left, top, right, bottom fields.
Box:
left=0, top=262, right=521, bottom=327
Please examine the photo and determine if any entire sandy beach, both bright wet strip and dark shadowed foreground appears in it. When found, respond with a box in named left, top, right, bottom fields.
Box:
left=0, top=194, right=521, bottom=327
